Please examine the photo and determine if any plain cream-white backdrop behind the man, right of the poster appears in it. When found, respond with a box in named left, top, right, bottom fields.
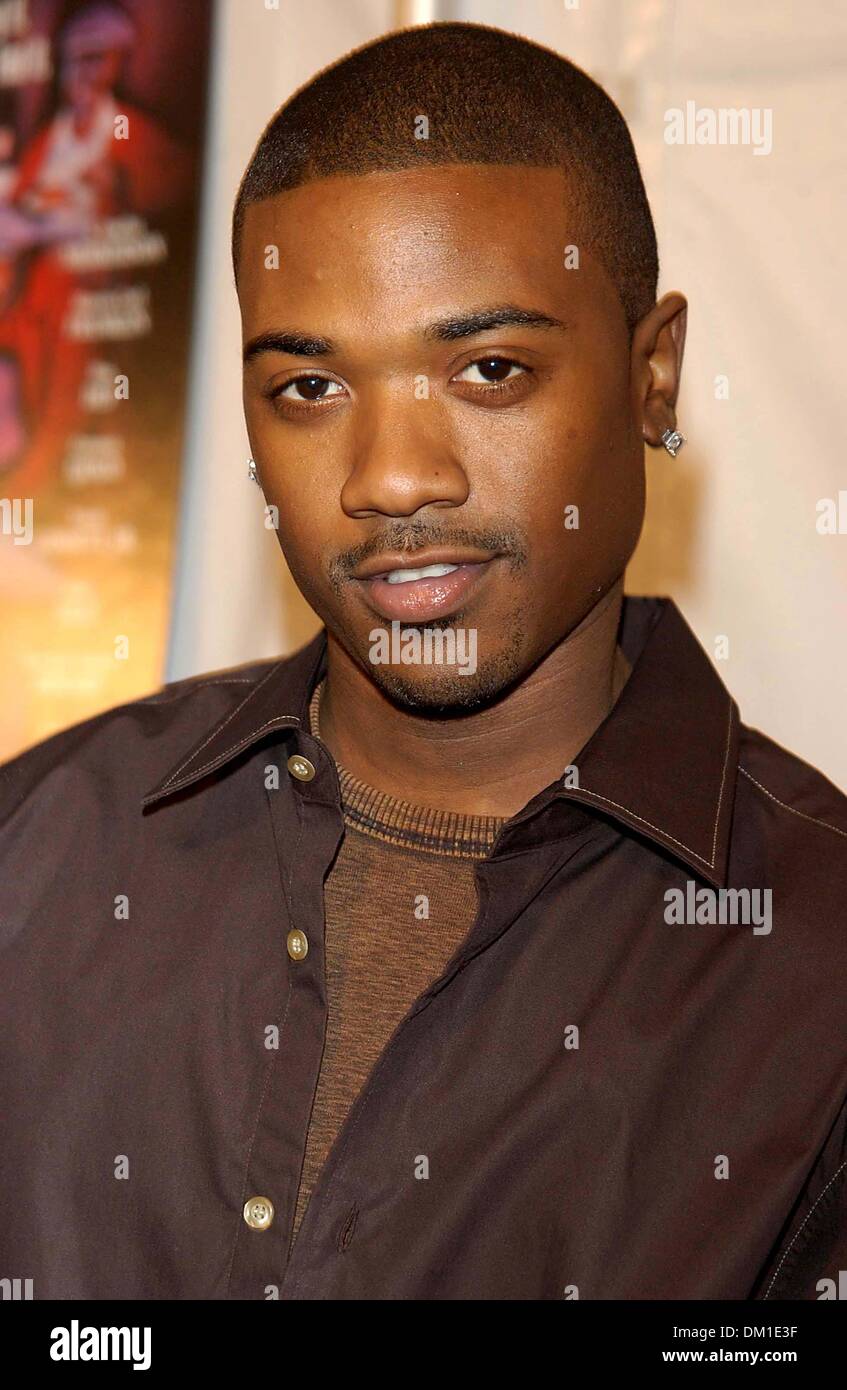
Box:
left=167, top=0, right=847, bottom=790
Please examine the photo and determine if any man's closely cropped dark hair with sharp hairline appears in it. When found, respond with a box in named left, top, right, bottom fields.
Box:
left=232, top=22, right=659, bottom=334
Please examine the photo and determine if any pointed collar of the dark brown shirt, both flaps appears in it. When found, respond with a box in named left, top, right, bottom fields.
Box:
left=142, top=596, right=740, bottom=887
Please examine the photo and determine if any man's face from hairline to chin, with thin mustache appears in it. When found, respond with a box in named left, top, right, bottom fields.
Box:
left=238, top=164, right=644, bottom=712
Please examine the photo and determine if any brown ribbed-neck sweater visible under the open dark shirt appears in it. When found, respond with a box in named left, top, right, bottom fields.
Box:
left=293, top=681, right=503, bottom=1237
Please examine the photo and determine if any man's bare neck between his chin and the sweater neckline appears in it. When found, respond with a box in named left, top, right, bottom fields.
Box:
left=320, top=580, right=629, bottom=817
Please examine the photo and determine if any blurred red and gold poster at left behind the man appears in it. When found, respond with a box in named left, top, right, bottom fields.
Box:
left=0, top=0, right=213, bottom=760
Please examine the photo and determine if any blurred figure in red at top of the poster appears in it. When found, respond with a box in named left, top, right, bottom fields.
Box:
left=0, top=0, right=192, bottom=489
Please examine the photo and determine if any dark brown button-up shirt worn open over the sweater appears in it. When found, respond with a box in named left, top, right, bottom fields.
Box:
left=0, top=599, right=847, bottom=1300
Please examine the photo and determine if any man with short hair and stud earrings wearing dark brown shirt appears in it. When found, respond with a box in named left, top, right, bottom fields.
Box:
left=0, top=24, right=847, bottom=1300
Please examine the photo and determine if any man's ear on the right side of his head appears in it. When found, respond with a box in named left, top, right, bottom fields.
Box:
left=631, top=291, right=688, bottom=448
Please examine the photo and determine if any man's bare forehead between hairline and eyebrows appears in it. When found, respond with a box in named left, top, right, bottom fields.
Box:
left=238, top=164, right=616, bottom=335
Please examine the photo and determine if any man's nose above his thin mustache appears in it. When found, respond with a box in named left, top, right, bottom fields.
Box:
left=341, top=384, right=470, bottom=517
